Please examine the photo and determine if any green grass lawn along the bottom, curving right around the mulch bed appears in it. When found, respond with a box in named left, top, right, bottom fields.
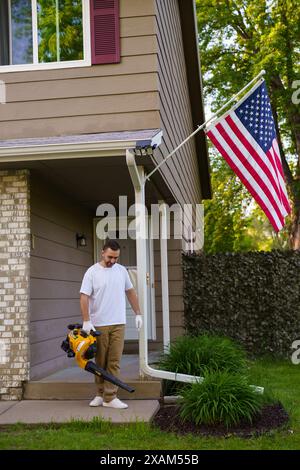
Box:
left=0, top=360, right=300, bottom=450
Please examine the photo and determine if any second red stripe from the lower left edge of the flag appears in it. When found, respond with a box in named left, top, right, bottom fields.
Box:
left=216, top=123, right=283, bottom=222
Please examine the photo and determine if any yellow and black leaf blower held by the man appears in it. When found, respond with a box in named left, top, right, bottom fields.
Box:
left=61, top=323, right=134, bottom=393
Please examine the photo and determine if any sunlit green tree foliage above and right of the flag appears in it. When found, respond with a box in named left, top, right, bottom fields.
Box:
left=197, top=0, right=300, bottom=249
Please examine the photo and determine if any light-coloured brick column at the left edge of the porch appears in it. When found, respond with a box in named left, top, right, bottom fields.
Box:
left=0, top=170, right=30, bottom=400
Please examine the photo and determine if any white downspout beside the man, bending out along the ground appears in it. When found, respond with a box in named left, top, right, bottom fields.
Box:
left=126, top=149, right=264, bottom=393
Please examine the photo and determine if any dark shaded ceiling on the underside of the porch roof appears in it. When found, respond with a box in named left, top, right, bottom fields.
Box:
left=0, top=157, right=172, bottom=212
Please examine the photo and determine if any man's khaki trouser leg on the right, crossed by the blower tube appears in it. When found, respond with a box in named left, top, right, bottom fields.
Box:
left=103, top=325, right=125, bottom=402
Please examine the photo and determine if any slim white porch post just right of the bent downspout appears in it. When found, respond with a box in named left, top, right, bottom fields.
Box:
left=159, top=201, right=170, bottom=352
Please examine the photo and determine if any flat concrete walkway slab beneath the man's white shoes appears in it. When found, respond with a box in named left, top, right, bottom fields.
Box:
left=0, top=400, right=159, bottom=425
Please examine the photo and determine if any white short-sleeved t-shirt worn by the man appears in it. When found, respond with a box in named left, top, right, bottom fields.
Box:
left=80, top=263, right=133, bottom=326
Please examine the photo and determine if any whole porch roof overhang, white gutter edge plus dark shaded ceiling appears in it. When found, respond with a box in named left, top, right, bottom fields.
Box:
left=0, top=129, right=173, bottom=211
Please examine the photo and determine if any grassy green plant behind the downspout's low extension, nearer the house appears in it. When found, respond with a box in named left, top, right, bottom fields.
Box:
left=158, top=335, right=246, bottom=395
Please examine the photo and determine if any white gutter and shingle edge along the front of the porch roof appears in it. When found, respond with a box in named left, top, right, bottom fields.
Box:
left=0, top=129, right=162, bottom=163
